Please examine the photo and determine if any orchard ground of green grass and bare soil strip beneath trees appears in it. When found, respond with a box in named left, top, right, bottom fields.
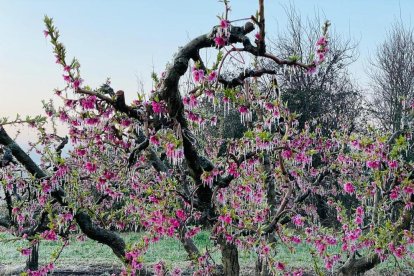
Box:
left=0, top=231, right=414, bottom=276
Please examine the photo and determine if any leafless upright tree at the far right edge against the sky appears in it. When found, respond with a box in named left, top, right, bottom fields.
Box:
left=369, top=23, right=414, bottom=132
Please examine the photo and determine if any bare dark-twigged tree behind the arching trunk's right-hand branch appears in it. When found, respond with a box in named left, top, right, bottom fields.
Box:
left=273, top=6, right=362, bottom=130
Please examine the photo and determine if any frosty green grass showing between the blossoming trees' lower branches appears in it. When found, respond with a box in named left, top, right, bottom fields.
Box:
left=0, top=231, right=413, bottom=271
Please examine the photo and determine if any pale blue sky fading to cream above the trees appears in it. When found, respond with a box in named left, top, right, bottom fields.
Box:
left=0, top=0, right=414, bottom=126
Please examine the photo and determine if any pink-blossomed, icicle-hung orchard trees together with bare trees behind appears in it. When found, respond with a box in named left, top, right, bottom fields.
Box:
left=0, top=0, right=414, bottom=275
